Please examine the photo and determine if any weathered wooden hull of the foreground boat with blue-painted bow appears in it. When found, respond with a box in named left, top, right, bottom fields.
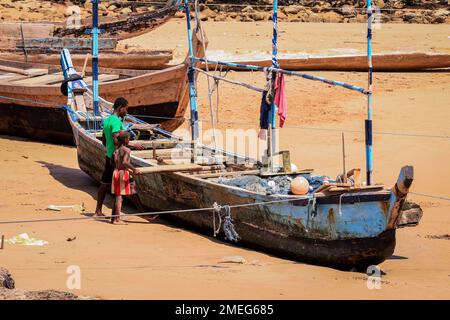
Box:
left=63, top=58, right=418, bottom=268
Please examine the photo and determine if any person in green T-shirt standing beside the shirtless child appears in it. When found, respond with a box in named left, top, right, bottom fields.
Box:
left=95, top=97, right=128, bottom=216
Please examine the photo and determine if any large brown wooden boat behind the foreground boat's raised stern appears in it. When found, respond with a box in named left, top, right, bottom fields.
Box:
left=0, top=31, right=203, bottom=144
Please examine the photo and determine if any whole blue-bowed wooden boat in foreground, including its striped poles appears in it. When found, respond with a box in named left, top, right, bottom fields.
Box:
left=61, top=0, right=422, bottom=268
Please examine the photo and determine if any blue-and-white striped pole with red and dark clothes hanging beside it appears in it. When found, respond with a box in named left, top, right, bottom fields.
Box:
left=267, top=0, right=278, bottom=171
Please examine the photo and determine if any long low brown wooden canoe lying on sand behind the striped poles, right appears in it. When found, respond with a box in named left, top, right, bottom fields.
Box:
left=209, top=53, right=450, bottom=71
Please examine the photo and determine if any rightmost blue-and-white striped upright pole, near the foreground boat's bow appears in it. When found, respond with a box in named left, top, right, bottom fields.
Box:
left=365, top=0, right=373, bottom=185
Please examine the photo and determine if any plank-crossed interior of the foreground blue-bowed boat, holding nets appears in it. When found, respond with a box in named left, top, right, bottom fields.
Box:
left=69, top=88, right=383, bottom=196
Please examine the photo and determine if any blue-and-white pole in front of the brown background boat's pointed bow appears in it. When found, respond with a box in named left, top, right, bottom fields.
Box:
left=184, top=0, right=199, bottom=163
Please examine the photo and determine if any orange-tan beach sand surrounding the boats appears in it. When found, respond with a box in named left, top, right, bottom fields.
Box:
left=0, top=21, right=450, bottom=299
